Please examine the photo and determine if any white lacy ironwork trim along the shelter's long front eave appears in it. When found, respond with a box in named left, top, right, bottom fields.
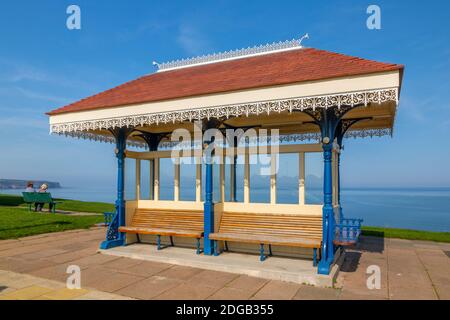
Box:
left=50, top=88, right=398, bottom=138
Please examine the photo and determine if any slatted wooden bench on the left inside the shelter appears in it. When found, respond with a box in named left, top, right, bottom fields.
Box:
left=119, top=209, right=203, bottom=254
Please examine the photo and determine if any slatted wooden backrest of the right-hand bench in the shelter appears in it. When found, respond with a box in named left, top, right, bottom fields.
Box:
left=219, top=212, right=322, bottom=240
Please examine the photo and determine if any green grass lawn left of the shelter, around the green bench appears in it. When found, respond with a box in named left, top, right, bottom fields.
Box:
left=0, top=195, right=110, bottom=239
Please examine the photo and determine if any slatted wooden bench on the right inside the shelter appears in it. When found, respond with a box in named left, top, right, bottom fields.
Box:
left=209, top=212, right=322, bottom=266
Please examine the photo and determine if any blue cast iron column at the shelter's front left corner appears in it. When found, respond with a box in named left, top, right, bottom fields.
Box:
left=100, top=128, right=128, bottom=249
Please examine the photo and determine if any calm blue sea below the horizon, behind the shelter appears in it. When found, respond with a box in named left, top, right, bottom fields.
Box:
left=0, top=186, right=450, bottom=232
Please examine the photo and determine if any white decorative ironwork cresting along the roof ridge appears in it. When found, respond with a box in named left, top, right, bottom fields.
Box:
left=153, top=38, right=308, bottom=72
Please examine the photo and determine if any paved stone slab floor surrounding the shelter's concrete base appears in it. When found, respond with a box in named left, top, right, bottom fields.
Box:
left=0, top=228, right=450, bottom=299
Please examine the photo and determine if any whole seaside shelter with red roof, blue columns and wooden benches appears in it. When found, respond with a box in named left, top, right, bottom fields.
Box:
left=48, top=40, right=403, bottom=274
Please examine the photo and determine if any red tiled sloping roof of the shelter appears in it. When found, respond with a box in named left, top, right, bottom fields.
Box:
left=48, top=48, right=403, bottom=115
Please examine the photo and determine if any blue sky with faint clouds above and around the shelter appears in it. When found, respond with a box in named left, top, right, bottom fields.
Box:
left=0, top=0, right=450, bottom=187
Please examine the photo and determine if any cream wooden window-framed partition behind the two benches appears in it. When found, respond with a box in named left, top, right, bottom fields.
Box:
left=126, top=144, right=330, bottom=215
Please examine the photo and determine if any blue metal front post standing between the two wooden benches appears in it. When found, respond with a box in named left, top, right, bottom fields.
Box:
left=203, top=143, right=214, bottom=256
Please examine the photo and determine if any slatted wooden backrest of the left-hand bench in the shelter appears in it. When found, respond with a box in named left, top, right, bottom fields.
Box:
left=131, top=209, right=203, bottom=232
